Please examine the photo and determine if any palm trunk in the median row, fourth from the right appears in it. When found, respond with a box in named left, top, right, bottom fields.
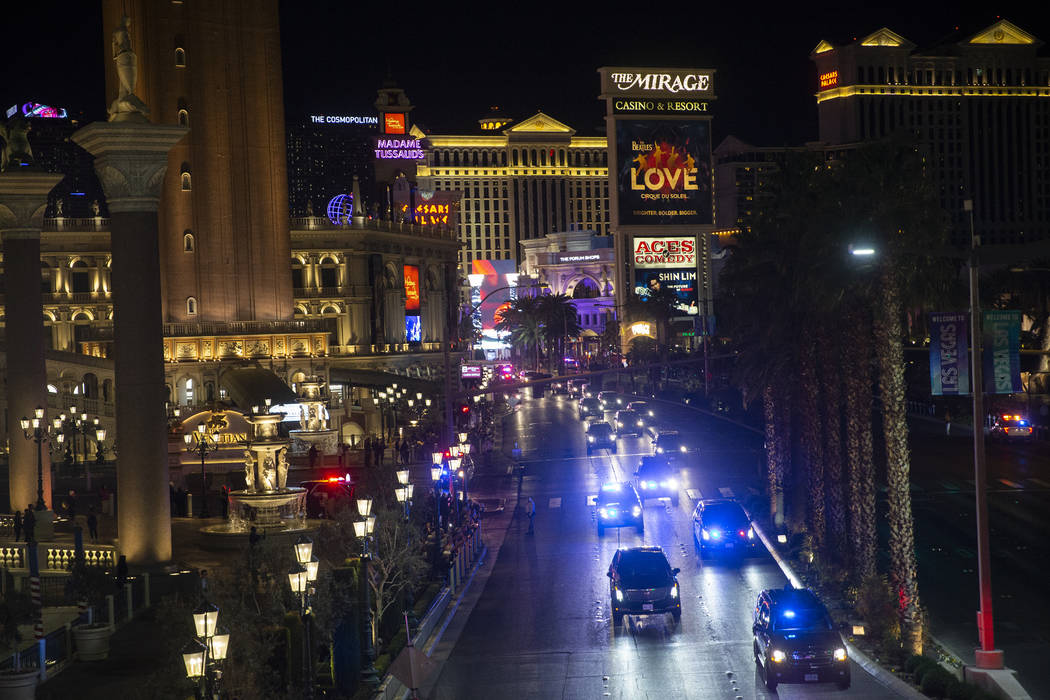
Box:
left=799, top=332, right=825, bottom=551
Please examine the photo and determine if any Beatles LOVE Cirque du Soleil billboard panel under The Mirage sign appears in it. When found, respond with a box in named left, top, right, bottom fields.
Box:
left=616, top=119, right=714, bottom=226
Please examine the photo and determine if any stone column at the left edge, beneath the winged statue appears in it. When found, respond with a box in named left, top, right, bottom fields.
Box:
left=0, top=170, right=62, bottom=520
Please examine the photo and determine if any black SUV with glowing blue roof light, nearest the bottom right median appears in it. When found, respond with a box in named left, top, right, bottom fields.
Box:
left=752, top=584, right=849, bottom=691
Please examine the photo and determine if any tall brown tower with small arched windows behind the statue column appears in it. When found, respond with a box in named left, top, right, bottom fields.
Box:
left=103, top=0, right=292, bottom=323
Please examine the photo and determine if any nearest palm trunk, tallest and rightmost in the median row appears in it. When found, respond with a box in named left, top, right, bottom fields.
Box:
left=875, top=264, right=922, bottom=654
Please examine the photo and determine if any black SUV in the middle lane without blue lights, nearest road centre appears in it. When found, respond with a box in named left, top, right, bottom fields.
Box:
left=607, top=547, right=681, bottom=624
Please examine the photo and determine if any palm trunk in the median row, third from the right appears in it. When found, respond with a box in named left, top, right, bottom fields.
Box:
left=818, top=332, right=847, bottom=564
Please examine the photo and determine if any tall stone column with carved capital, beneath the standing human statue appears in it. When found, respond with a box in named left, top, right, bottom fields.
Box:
left=72, top=122, right=188, bottom=566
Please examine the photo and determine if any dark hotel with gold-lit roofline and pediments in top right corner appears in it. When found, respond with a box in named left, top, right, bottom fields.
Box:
left=812, top=20, right=1050, bottom=246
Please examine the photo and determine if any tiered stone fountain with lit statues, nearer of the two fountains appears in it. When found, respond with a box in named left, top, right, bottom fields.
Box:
left=201, top=405, right=308, bottom=548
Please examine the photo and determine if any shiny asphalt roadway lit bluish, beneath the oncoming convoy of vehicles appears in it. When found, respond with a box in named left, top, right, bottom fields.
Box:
left=431, top=397, right=907, bottom=700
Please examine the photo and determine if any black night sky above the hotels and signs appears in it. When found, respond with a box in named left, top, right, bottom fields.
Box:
left=0, top=0, right=1050, bottom=146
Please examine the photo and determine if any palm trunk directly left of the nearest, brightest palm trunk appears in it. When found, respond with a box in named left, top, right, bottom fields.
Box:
left=842, top=310, right=877, bottom=582
